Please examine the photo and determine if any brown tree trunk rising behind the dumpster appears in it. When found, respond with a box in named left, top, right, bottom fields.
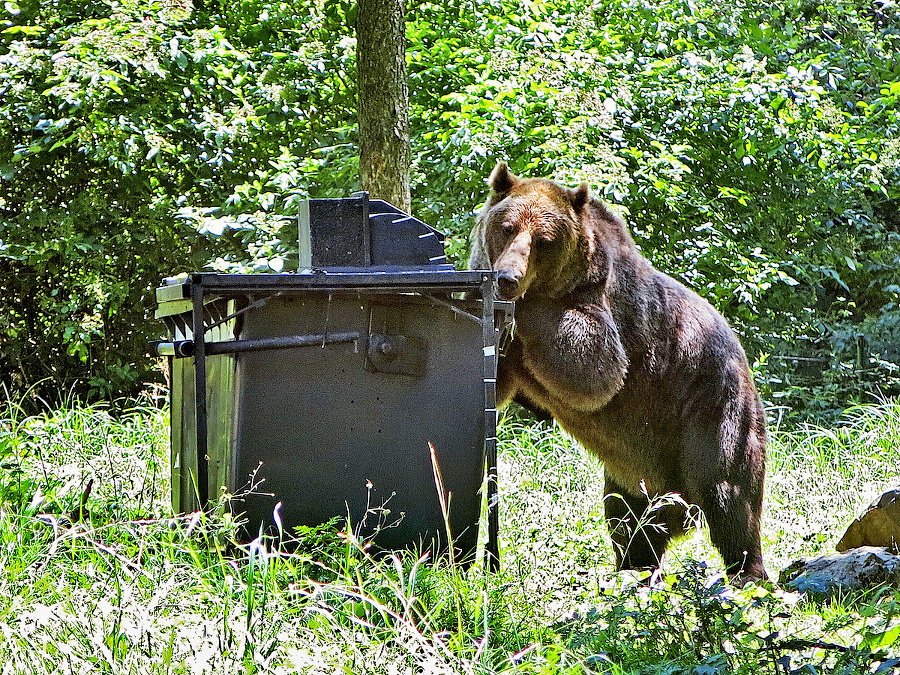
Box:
left=356, top=0, right=410, bottom=213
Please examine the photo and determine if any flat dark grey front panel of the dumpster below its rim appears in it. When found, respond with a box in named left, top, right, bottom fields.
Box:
left=233, top=293, right=484, bottom=554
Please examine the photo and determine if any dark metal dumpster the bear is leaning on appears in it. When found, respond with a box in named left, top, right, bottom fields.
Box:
left=157, top=194, right=511, bottom=563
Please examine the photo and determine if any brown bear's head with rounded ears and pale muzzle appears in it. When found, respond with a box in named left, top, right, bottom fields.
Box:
left=477, top=162, right=596, bottom=300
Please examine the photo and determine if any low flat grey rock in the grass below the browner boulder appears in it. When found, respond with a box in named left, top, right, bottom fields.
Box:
left=778, top=546, right=900, bottom=599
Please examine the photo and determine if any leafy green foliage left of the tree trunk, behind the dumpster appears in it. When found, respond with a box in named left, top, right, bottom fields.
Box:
left=0, top=0, right=355, bottom=400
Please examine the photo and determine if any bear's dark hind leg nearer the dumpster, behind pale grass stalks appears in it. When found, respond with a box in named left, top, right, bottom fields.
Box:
left=603, top=475, right=685, bottom=570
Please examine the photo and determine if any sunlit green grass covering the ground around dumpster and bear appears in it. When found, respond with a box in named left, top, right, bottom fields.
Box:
left=0, top=402, right=900, bottom=675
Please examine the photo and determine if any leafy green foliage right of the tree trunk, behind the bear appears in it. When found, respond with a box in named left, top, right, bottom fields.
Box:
left=410, top=0, right=900, bottom=417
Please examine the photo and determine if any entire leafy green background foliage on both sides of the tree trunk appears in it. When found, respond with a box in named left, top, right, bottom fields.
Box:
left=0, top=0, right=900, bottom=418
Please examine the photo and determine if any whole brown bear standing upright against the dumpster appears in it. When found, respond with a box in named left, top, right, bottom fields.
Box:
left=469, top=162, right=767, bottom=583
